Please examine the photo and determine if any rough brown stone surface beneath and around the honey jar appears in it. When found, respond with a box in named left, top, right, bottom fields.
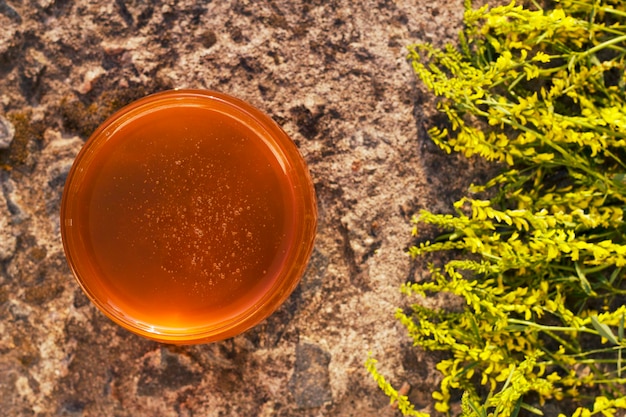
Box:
left=0, top=0, right=492, bottom=417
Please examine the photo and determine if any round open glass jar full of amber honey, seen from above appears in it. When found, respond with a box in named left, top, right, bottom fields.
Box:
left=61, top=90, right=316, bottom=343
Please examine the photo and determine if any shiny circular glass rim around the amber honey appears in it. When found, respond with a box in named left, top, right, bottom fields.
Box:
left=60, top=89, right=317, bottom=344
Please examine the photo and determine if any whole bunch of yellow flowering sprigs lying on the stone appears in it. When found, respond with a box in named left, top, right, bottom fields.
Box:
left=366, top=0, right=626, bottom=417
